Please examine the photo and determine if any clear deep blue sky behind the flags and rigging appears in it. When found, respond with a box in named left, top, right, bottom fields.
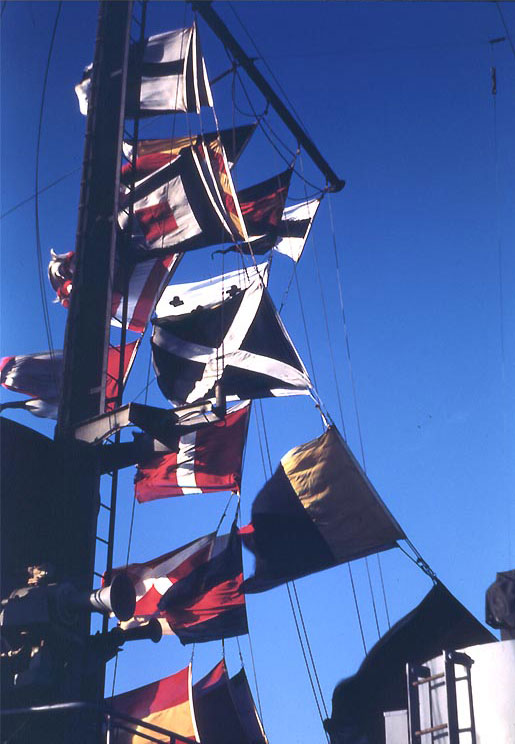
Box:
left=0, top=2, right=515, bottom=744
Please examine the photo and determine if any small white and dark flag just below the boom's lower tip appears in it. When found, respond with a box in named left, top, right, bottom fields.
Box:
left=227, top=199, right=320, bottom=262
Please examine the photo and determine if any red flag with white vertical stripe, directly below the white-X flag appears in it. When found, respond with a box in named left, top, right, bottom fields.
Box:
left=134, top=401, right=250, bottom=502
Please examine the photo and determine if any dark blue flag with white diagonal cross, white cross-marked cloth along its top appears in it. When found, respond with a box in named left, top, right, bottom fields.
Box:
left=152, top=264, right=311, bottom=403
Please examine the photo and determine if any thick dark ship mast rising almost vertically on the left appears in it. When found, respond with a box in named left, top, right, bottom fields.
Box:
left=56, top=0, right=132, bottom=742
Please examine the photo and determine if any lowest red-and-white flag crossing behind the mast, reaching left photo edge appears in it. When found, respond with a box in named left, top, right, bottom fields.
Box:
left=0, top=340, right=139, bottom=418
